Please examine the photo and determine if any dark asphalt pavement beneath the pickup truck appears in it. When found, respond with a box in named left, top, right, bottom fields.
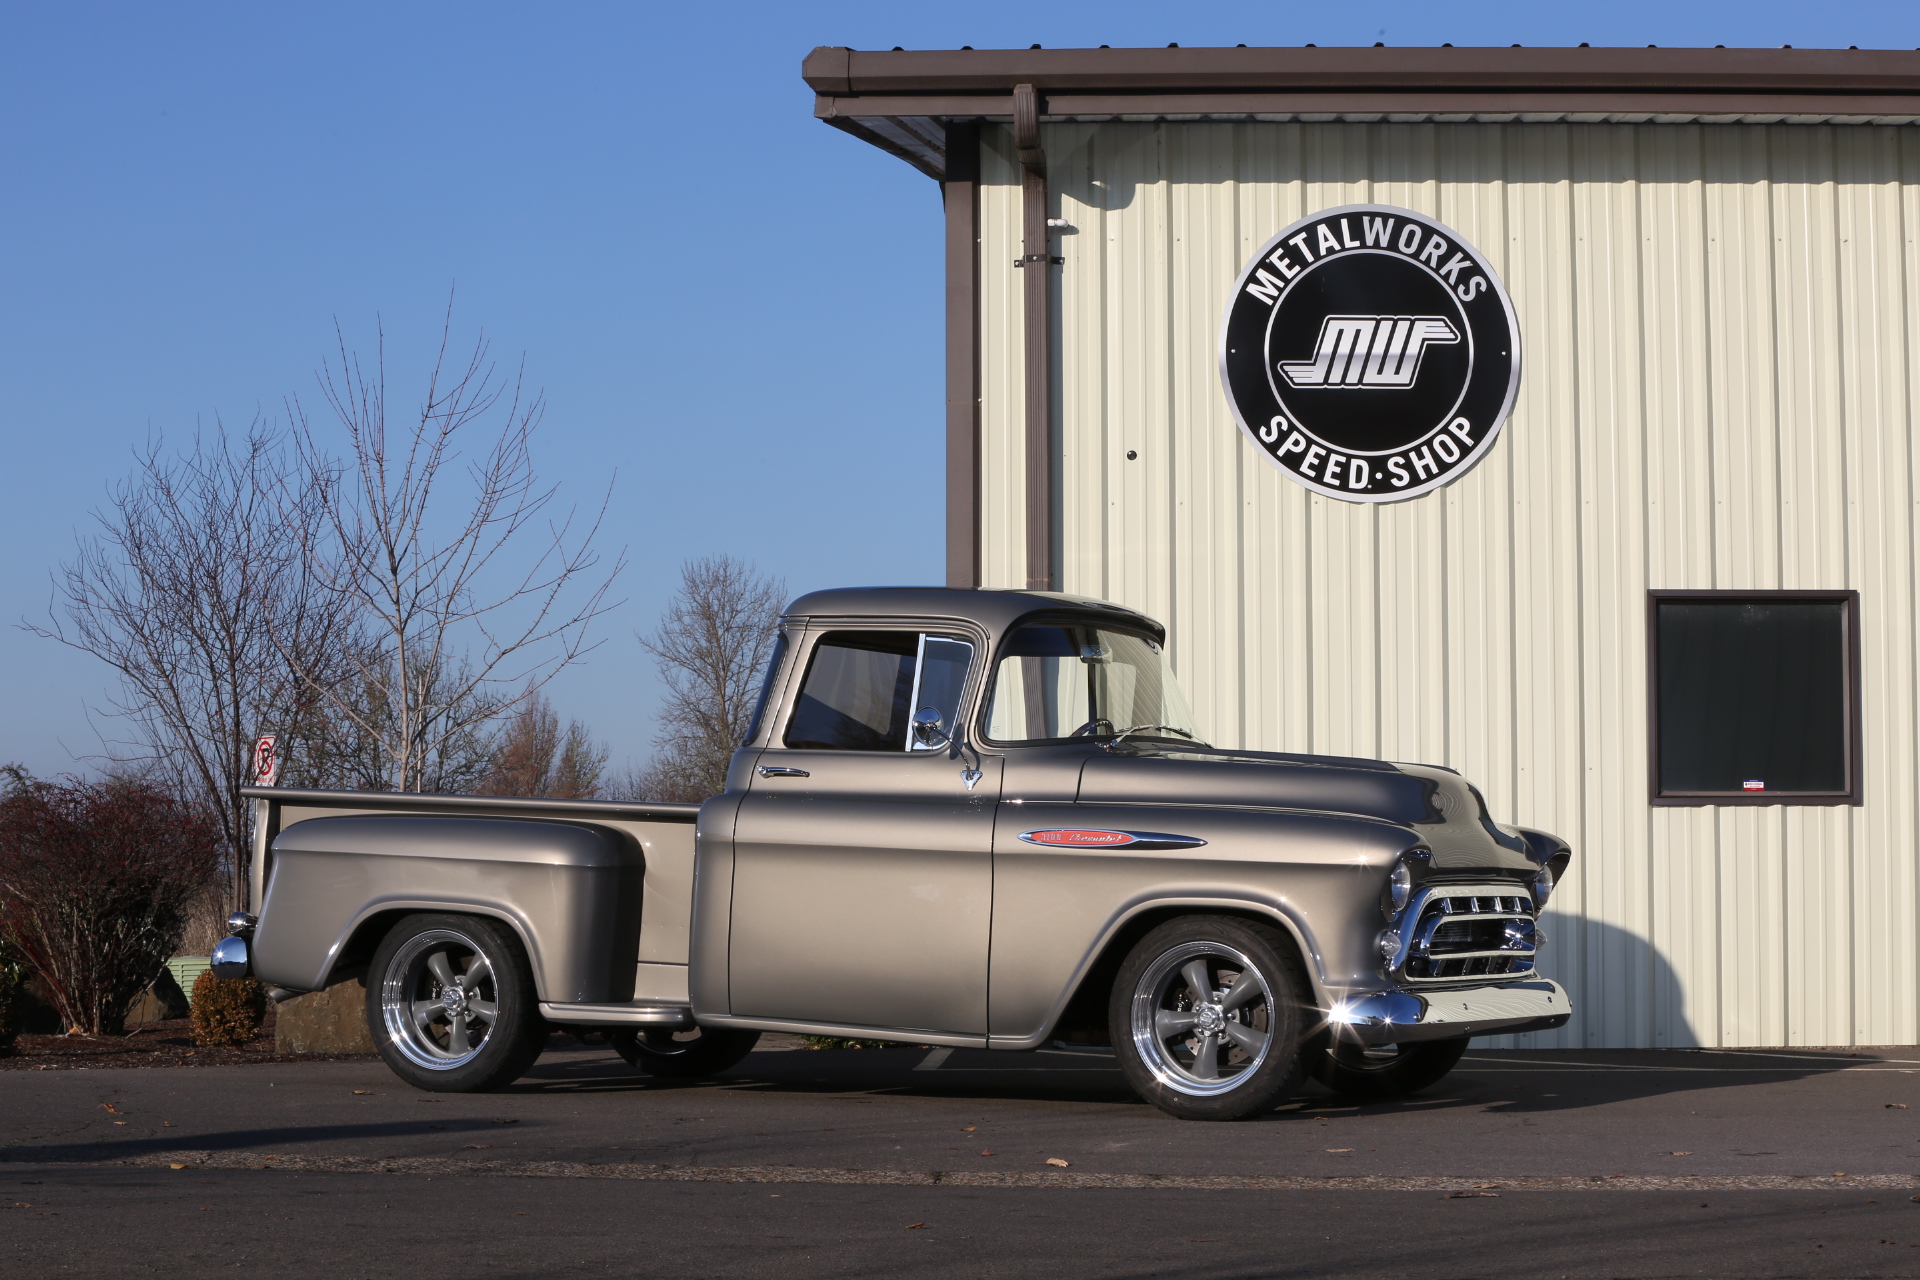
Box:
left=0, top=1038, right=1920, bottom=1280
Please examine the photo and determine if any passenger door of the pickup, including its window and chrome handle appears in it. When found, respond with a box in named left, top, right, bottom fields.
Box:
left=728, top=629, right=1000, bottom=1034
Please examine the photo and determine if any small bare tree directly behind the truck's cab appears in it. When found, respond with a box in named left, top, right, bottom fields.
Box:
left=632, top=555, right=787, bottom=800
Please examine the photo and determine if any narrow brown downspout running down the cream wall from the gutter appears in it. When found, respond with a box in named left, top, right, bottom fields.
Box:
left=1014, top=84, right=1058, bottom=591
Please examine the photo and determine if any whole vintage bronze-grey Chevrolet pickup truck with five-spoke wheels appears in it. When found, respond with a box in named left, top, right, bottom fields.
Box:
left=215, top=587, right=1571, bottom=1119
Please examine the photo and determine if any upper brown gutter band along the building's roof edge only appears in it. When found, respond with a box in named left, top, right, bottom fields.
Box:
left=801, top=48, right=1920, bottom=96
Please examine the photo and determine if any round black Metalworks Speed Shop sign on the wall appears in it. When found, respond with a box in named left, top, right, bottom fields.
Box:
left=1219, top=205, right=1521, bottom=503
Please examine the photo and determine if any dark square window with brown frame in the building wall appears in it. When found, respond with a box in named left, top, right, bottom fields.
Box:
left=1647, top=591, right=1860, bottom=804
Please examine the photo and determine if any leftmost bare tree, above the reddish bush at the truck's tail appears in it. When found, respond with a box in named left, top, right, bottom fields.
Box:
left=27, top=418, right=351, bottom=913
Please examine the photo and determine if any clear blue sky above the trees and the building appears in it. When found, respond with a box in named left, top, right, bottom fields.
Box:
left=0, top=0, right=1920, bottom=771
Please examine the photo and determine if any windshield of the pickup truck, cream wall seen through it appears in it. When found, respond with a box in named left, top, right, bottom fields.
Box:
left=987, top=626, right=1200, bottom=743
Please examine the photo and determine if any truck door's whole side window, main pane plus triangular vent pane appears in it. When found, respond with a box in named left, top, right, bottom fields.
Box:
left=781, top=631, right=973, bottom=752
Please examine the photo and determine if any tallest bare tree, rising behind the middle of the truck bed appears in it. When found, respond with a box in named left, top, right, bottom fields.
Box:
left=282, top=317, right=622, bottom=791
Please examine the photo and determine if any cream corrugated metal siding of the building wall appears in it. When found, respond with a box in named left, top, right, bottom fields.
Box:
left=981, top=123, right=1920, bottom=1046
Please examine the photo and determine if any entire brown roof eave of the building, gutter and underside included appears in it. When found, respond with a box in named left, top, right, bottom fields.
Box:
left=801, top=48, right=1920, bottom=178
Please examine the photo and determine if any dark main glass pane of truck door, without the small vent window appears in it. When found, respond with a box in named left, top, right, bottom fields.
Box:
left=785, top=631, right=920, bottom=750
